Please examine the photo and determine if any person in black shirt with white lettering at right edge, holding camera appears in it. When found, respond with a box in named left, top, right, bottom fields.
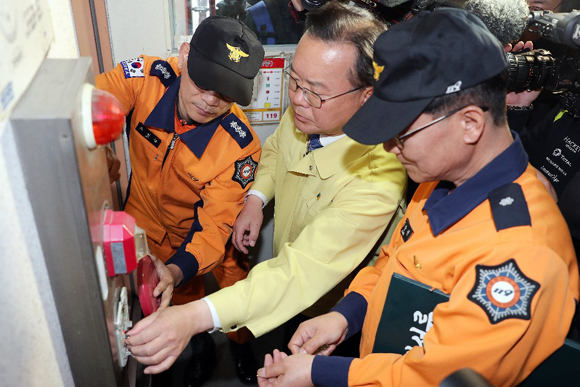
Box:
left=507, top=0, right=580, bottom=278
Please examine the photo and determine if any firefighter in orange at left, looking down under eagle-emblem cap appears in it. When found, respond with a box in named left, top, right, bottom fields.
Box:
left=96, top=16, right=264, bottom=387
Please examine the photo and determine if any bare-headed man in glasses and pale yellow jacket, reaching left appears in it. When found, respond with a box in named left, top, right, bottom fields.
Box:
left=127, top=2, right=406, bottom=373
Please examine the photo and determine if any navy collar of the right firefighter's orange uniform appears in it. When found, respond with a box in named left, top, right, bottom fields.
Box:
left=423, top=131, right=528, bottom=236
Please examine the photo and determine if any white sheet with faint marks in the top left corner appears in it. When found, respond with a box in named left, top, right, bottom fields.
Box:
left=0, top=0, right=53, bottom=122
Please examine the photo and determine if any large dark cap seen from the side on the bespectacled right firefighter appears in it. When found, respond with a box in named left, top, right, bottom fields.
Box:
left=343, top=8, right=507, bottom=145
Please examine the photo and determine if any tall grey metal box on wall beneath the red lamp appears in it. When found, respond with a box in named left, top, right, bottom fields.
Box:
left=10, top=58, right=137, bottom=386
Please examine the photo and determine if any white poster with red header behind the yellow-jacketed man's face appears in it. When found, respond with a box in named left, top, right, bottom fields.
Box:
left=242, top=57, right=286, bottom=124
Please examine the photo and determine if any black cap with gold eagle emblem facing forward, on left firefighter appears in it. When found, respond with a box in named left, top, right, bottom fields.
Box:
left=187, top=16, right=264, bottom=105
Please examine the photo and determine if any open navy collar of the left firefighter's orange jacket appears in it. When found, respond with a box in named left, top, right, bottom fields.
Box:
left=145, top=76, right=229, bottom=158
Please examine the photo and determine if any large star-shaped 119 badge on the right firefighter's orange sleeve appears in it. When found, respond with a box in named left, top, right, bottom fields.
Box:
left=468, top=259, right=540, bottom=324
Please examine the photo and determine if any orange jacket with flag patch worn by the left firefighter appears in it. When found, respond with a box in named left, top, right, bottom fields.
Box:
left=96, top=56, right=261, bottom=280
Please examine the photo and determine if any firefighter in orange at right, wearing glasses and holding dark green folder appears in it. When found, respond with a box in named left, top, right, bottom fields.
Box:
left=258, top=8, right=579, bottom=387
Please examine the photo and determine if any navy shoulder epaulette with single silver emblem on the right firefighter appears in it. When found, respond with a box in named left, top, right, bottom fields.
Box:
left=488, top=183, right=532, bottom=231
